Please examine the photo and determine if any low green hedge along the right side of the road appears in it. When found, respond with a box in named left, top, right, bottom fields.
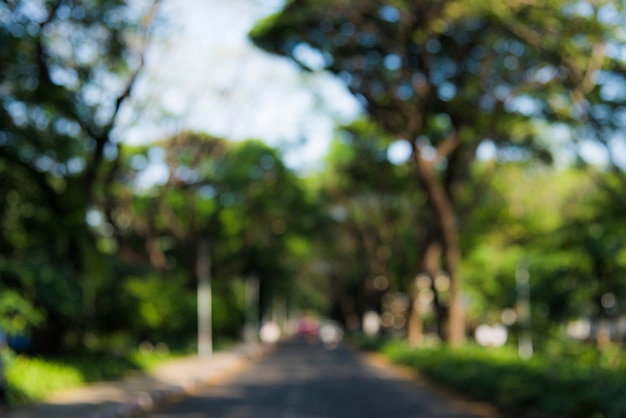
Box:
left=360, top=341, right=626, bottom=418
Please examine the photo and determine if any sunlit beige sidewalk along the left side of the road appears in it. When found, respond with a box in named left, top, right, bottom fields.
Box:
left=0, top=345, right=271, bottom=418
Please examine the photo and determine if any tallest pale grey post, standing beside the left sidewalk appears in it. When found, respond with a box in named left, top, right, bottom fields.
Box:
left=196, top=238, right=213, bottom=357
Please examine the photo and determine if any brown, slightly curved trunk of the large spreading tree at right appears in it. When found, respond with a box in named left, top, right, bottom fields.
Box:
left=416, top=153, right=465, bottom=345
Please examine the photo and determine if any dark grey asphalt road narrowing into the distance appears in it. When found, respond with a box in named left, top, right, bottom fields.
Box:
left=148, top=341, right=494, bottom=418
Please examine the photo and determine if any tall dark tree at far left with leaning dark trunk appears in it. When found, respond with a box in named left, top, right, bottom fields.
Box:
left=0, top=0, right=156, bottom=350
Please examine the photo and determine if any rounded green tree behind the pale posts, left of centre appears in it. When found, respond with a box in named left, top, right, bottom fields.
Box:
left=105, top=132, right=312, bottom=337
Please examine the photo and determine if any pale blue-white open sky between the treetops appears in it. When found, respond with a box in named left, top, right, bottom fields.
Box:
left=125, top=0, right=361, bottom=176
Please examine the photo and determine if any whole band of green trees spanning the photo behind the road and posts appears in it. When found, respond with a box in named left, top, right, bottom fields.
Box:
left=0, top=0, right=626, bottom=352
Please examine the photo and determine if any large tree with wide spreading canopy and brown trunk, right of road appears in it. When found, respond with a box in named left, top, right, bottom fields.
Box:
left=251, top=0, right=624, bottom=344
